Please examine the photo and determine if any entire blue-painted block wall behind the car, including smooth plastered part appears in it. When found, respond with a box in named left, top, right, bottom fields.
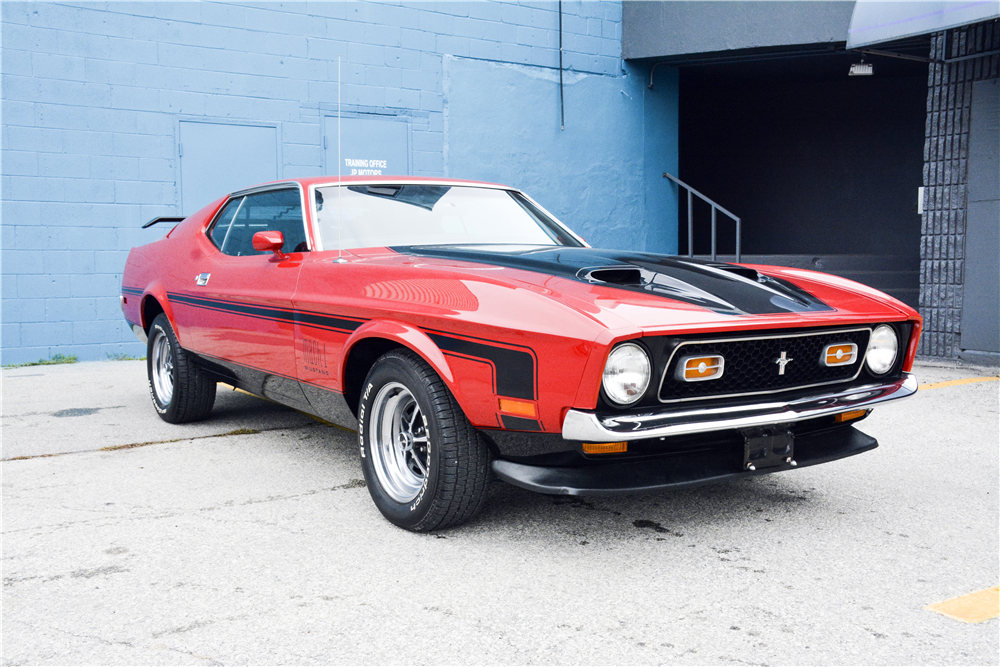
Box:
left=0, top=1, right=677, bottom=364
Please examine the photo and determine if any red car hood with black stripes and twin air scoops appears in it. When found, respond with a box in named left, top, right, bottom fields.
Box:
left=380, top=245, right=908, bottom=331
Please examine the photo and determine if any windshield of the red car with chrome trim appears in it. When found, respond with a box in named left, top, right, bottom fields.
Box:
left=315, top=184, right=581, bottom=250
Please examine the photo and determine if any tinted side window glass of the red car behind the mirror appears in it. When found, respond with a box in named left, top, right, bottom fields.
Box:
left=208, top=190, right=309, bottom=257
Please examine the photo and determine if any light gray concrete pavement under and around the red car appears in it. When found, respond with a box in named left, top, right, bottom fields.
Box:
left=0, top=361, right=1000, bottom=665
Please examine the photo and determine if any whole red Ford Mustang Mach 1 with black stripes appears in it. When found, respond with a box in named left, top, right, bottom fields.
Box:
left=122, top=177, right=921, bottom=531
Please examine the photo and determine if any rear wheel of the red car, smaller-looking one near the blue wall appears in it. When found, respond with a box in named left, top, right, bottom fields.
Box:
left=146, top=313, right=215, bottom=424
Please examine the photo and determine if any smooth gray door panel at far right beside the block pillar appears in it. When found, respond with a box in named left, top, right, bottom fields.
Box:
left=962, top=79, right=1000, bottom=353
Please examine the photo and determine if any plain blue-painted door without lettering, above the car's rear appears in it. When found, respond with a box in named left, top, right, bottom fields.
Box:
left=178, top=121, right=278, bottom=215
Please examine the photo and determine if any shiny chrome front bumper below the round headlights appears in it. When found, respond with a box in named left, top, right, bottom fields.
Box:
left=562, top=373, right=917, bottom=442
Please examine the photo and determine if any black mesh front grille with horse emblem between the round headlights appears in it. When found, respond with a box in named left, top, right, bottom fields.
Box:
left=659, top=327, right=871, bottom=403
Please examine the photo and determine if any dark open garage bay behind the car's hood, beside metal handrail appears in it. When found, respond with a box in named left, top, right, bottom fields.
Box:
left=669, top=51, right=927, bottom=306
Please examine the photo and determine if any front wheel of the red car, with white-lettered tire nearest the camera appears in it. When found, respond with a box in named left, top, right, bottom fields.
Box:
left=358, top=350, right=490, bottom=532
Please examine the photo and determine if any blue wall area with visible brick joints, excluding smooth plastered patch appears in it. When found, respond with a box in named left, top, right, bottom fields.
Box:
left=0, top=1, right=676, bottom=364
